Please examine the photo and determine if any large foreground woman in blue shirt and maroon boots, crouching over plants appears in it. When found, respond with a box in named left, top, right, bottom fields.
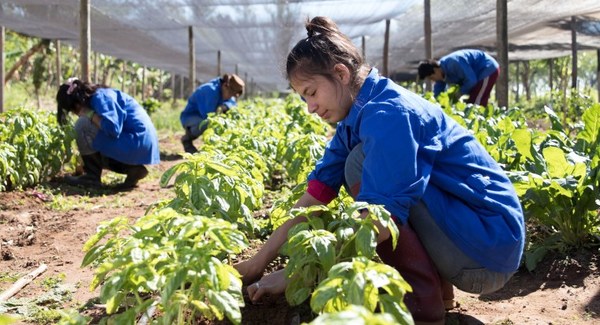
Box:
left=235, top=17, right=525, bottom=324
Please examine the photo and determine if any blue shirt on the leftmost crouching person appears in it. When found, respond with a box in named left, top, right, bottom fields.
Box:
left=90, top=88, right=160, bottom=165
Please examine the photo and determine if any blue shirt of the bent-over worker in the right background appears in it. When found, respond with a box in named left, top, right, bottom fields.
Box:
left=433, top=50, right=498, bottom=96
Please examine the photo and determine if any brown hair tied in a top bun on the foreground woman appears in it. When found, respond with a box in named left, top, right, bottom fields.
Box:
left=286, top=17, right=368, bottom=89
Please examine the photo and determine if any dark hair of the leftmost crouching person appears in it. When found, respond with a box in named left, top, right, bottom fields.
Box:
left=56, top=79, right=107, bottom=125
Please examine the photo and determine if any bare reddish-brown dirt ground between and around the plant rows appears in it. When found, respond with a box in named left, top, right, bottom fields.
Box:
left=0, top=135, right=600, bottom=325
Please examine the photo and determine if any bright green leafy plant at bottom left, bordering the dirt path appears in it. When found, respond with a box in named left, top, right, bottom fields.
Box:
left=82, top=208, right=248, bottom=324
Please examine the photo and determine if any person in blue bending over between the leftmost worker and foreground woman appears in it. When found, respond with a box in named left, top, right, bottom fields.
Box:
left=179, top=74, right=244, bottom=153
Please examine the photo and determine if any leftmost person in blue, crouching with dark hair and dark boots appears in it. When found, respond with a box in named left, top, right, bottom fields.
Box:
left=56, top=79, right=160, bottom=189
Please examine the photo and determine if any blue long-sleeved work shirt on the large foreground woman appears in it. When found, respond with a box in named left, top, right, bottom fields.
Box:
left=309, top=69, right=525, bottom=272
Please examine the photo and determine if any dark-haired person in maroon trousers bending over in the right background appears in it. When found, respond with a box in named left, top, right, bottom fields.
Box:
left=418, top=50, right=500, bottom=106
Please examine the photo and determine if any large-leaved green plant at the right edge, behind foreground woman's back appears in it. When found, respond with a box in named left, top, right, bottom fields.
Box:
left=511, top=104, right=600, bottom=264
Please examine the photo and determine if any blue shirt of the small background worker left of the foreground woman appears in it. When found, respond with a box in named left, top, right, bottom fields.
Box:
left=179, top=78, right=237, bottom=127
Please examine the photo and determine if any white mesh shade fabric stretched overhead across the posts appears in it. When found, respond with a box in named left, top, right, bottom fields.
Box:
left=0, top=0, right=600, bottom=91
